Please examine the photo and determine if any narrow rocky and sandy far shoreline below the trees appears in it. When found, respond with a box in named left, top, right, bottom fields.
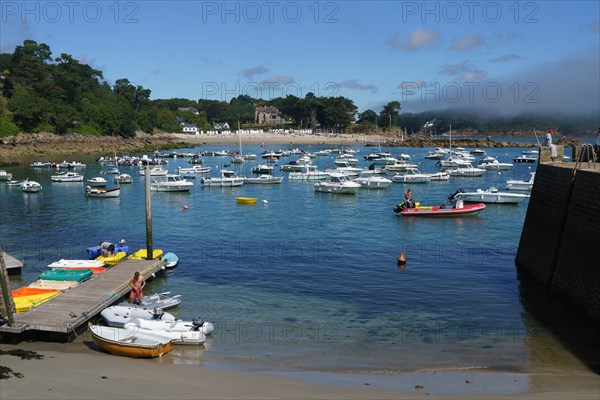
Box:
left=0, top=133, right=578, bottom=163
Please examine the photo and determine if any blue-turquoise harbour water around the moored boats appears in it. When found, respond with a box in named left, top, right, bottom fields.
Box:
left=0, top=146, right=572, bottom=371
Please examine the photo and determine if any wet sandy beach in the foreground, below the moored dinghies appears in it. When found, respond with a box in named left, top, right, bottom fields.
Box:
left=0, top=337, right=600, bottom=399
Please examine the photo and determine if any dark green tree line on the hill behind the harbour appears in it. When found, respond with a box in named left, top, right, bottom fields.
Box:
left=0, top=40, right=597, bottom=137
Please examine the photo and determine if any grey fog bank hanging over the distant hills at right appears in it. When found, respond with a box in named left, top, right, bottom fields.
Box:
left=400, top=49, right=600, bottom=117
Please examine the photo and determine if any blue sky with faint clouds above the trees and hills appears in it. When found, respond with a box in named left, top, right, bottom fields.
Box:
left=0, top=0, right=600, bottom=114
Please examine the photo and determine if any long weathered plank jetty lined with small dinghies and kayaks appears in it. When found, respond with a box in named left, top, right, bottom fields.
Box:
left=0, top=260, right=166, bottom=341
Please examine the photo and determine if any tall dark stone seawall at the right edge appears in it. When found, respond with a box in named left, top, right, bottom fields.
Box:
left=515, top=163, right=600, bottom=329
